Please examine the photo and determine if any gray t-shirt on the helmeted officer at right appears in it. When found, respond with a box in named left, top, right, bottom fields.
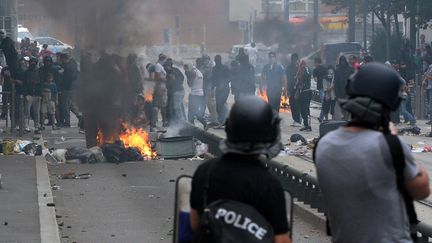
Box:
left=316, top=128, right=419, bottom=243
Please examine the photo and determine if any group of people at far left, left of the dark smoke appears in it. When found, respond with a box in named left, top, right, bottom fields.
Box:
left=0, top=31, right=82, bottom=133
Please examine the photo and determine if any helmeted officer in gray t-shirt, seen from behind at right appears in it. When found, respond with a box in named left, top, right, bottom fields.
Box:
left=315, top=63, right=430, bottom=243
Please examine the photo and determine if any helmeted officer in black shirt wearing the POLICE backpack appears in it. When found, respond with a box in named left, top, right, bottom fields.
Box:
left=190, top=96, right=291, bottom=243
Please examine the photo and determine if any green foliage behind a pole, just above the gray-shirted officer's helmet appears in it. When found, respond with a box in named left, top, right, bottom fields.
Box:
left=370, top=29, right=404, bottom=62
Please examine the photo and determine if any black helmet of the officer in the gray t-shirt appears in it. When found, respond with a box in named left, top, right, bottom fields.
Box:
left=347, top=63, right=404, bottom=111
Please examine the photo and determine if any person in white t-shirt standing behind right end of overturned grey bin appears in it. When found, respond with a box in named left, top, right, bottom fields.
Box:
left=184, top=65, right=208, bottom=130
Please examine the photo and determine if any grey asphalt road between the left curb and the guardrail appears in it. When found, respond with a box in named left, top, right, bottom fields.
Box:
left=49, top=160, right=328, bottom=243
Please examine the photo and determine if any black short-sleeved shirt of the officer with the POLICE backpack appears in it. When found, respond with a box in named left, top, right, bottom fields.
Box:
left=190, top=154, right=289, bottom=235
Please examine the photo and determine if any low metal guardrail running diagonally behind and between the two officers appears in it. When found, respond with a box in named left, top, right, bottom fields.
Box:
left=180, top=123, right=432, bottom=242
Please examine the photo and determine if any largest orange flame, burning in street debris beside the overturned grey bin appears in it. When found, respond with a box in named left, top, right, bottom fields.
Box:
left=119, top=123, right=157, bottom=159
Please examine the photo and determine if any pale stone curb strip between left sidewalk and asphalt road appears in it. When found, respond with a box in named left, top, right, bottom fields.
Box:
left=35, top=156, right=60, bottom=243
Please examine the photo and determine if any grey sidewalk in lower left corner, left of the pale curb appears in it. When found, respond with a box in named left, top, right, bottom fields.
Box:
left=0, top=155, right=41, bottom=243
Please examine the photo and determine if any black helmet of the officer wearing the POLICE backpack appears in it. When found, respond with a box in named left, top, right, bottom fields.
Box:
left=225, top=96, right=280, bottom=143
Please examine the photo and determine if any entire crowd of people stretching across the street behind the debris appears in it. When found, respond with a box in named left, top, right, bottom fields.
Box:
left=0, top=28, right=432, bottom=140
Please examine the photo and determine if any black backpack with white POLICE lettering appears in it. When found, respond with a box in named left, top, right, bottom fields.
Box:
left=193, top=164, right=273, bottom=243
